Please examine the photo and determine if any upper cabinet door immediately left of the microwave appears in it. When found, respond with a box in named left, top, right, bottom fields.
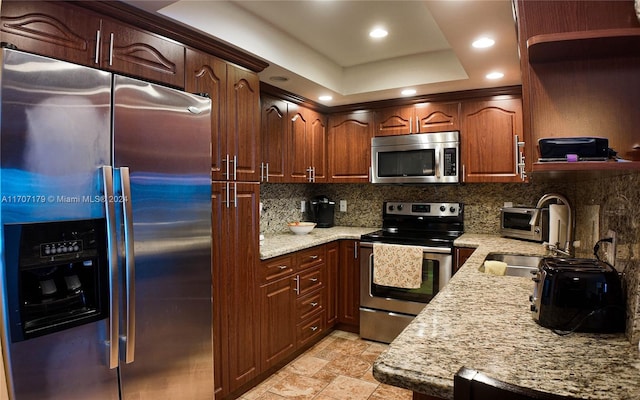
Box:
left=328, top=111, right=373, bottom=183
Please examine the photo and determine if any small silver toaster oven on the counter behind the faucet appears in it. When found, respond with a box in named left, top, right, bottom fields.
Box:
left=500, top=207, right=549, bottom=243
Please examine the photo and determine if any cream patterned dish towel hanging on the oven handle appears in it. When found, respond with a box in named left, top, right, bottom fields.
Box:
left=373, top=243, right=423, bottom=289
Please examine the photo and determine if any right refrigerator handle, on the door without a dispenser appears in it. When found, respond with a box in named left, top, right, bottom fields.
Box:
left=118, top=167, right=136, bottom=364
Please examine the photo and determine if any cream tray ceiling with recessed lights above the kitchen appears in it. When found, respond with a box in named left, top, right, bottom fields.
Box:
left=125, top=0, right=521, bottom=106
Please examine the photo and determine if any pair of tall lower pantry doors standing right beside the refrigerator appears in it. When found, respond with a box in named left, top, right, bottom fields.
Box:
left=212, top=182, right=260, bottom=396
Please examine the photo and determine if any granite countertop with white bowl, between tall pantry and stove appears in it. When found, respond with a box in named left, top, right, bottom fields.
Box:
left=260, top=226, right=380, bottom=260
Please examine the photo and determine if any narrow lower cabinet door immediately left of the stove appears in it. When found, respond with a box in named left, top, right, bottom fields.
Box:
left=338, top=240, right=360, bottom=332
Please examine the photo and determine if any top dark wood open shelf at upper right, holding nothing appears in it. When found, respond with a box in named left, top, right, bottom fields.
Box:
left=527, top=28, right=640, bottom=63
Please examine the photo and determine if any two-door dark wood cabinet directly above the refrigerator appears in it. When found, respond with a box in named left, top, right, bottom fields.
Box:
left=2, top=1, right=184, bottom=88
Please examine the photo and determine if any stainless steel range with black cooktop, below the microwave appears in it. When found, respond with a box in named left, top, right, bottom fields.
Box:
left=360, top=202, right=464, bottom=343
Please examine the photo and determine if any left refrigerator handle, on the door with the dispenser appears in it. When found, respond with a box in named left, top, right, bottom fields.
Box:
left=102, top=165, right=120, bottom=369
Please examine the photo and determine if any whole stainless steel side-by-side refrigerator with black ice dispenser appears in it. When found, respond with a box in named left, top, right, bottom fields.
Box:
left=0, top=49, right=213, bottom=400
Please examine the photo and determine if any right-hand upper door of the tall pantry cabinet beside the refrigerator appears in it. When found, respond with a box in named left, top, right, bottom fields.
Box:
left=227, top=64, right=260, bottom=182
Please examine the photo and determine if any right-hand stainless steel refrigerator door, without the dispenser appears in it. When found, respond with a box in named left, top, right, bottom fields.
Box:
left=113, top=76, right=213, bottom=400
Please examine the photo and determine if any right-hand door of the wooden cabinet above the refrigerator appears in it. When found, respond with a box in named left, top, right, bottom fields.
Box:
left=101, top=19, right=184, bottom=88
